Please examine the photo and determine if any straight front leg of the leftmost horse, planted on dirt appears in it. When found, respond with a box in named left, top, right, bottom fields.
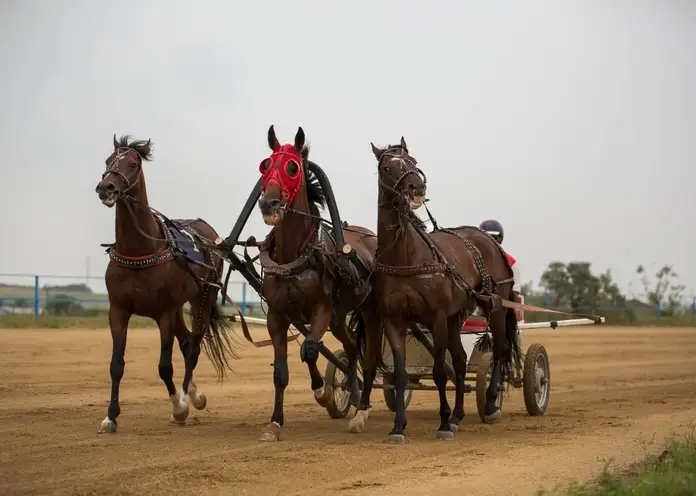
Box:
left=99, top=303, right=131, bottom=433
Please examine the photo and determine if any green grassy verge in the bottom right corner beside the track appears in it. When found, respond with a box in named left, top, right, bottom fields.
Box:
left=537, top=433, right=696, bottom=496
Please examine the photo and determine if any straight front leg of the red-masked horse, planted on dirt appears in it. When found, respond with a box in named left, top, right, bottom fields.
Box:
left=259, top=311, right=290, bottom=441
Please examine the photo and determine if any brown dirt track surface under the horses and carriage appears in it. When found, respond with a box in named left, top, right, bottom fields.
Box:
left=0, top=326, right=696, bottom=496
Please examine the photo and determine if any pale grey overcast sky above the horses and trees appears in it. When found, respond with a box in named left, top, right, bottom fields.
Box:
left=0, top=0, right=696, bottom=300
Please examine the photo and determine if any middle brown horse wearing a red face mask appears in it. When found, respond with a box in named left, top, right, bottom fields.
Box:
left=251, top=126, right=379, bottom=441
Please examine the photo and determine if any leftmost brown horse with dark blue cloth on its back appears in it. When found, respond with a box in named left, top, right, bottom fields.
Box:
left=96, top=135, right=235, bottom=432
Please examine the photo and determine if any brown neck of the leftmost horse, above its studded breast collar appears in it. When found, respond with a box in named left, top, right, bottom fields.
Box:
left=115, top=177, right=163, bottom=257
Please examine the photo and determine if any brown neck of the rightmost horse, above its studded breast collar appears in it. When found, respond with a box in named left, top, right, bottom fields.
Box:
left=376, top=192, right=432, bottom=266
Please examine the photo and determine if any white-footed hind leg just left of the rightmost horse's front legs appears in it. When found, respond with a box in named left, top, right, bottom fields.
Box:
left=348, top=307, right=382, bottom=433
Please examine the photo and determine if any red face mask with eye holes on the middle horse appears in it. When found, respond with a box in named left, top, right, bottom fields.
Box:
left=259, top=145, right=304, bottom=205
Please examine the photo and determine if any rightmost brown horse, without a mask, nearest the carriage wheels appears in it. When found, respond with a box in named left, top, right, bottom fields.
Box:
left=351, top=137, right=519, bottom=443
